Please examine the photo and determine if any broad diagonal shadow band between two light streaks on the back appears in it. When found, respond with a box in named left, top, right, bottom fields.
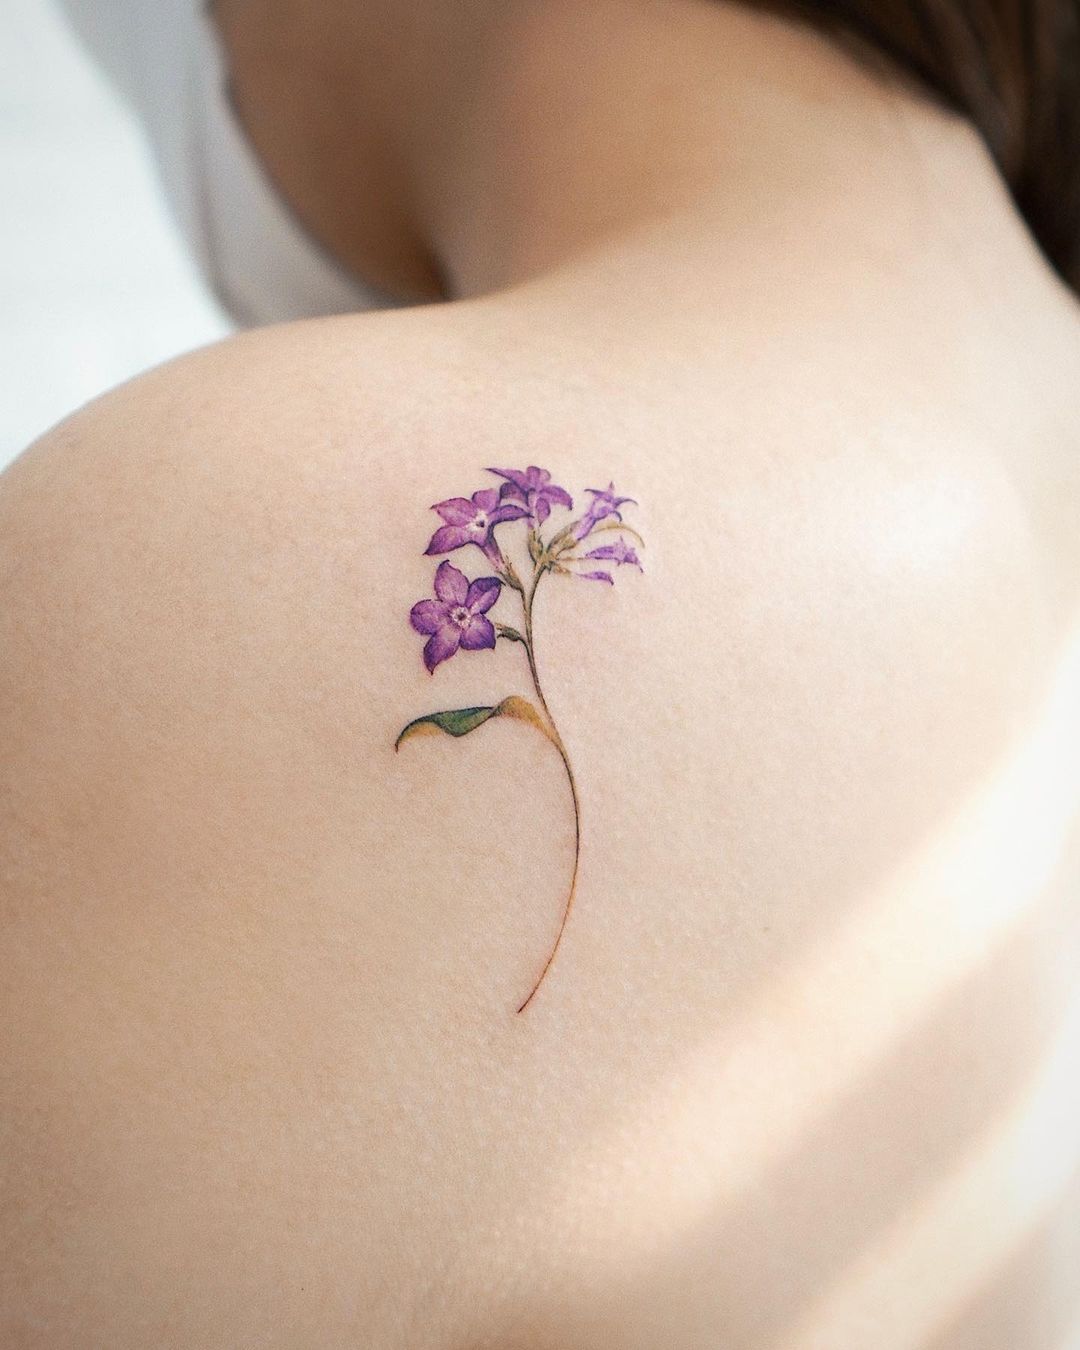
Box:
left=497, top=885, right=1069, bottom=1350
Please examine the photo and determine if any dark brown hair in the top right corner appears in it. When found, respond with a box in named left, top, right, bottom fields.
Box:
left=761, top=0, right=1080, bottom=290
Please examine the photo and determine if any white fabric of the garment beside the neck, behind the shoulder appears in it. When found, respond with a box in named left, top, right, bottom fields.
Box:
left=52, top=0, right=398, bottom=324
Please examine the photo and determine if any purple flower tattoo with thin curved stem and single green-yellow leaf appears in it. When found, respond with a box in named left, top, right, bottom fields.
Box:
left=394, top=464, right=644, bottom=1013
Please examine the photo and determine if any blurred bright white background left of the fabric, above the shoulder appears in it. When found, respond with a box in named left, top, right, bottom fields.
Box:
left=0, top=0, right=231, bottom=468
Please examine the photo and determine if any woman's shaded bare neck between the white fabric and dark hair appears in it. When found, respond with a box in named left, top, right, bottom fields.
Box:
left=217, top=0, right=1058, bottom=320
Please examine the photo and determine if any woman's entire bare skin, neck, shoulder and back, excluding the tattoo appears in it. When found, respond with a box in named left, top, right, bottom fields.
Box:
left=0, top=0, right=1080, bottom=1350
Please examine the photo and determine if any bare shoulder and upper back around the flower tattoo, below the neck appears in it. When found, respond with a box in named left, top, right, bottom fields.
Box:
left=0, top=316, right=1080, bottom=1350
